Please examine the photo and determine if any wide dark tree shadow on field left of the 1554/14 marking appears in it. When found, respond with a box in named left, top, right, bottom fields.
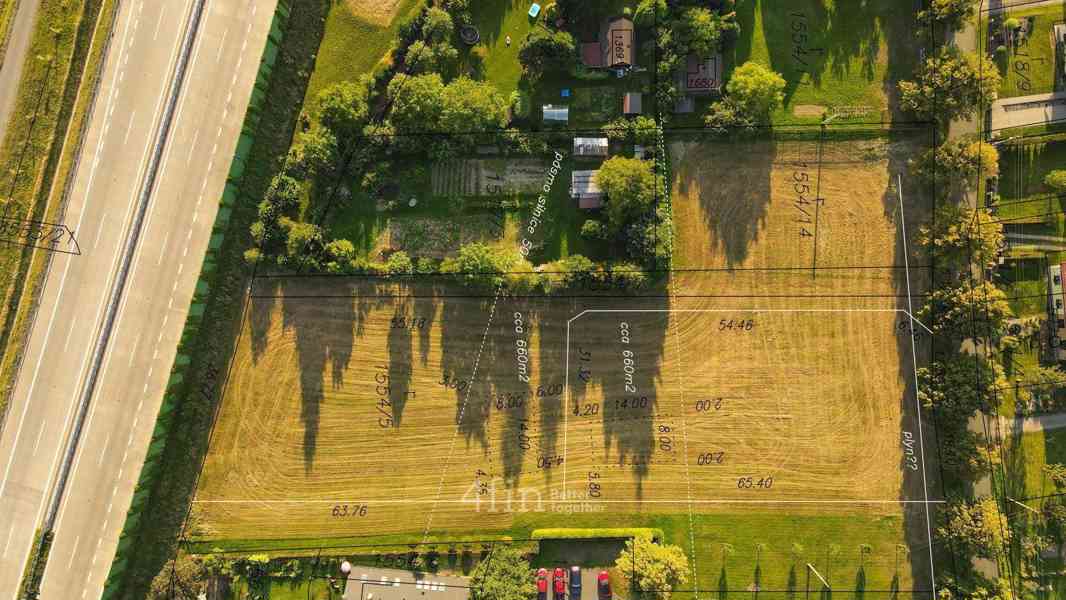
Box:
left=672, top=137, right=776, bottom=269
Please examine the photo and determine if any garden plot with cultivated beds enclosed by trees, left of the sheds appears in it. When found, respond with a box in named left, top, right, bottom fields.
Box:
left=327, top=149, right=610, bottom=264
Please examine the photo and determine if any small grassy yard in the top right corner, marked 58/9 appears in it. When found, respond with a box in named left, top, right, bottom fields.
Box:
left=982, top=5, right=1066, bottom=98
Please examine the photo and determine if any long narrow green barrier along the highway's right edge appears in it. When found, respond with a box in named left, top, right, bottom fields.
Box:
left=101, top=0, right=289, bottom=600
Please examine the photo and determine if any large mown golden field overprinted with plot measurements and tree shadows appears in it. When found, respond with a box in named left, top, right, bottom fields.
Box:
left=194, top=137, right=922, bottom=539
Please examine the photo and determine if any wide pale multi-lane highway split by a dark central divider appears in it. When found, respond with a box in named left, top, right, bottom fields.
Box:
left=0, top=0, right=276, bottom=599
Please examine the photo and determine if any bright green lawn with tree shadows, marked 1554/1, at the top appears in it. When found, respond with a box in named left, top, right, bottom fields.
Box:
left=726, top=0, right=923, bottom=124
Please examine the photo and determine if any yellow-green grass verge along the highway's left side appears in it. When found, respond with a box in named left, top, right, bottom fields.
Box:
left=0, top=0, right=116, bottom=422
